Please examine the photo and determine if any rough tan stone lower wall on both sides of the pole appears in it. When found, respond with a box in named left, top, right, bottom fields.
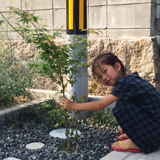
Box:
left=2, top=37, right=160, bottom=96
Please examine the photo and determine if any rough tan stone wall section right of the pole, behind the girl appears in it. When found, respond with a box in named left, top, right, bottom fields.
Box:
left=88, top=37, right=160, bottom=96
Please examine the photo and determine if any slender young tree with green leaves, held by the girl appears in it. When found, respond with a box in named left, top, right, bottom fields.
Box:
left=0, top=6, right=100, bottom=149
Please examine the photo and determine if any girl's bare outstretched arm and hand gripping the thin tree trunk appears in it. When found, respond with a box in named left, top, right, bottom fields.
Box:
left=61, top=94, right=118, bottom=111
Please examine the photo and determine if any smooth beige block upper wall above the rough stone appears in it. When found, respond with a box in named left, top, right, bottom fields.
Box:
left=0, top=0, right=160, bottom=38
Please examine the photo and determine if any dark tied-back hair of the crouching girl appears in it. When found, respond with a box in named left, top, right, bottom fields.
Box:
left=92, top=53, right=126, bottom=76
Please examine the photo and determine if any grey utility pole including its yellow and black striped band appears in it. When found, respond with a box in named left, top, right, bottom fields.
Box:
left=66, top=0, right=88, bottom=117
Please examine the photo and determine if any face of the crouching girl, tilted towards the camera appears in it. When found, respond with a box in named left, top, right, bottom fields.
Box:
left=95, top=62, right=123, bottom=86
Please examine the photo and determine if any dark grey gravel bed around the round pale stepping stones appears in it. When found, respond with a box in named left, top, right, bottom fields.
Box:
left=0, top=123, right=119, bottom=160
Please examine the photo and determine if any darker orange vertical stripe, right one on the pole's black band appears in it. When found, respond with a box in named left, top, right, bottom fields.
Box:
left=79, top=0, right=84, bottom=29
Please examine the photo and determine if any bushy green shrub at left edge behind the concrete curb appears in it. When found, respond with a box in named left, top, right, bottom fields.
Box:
left=0, top=40, right=32, bottom=106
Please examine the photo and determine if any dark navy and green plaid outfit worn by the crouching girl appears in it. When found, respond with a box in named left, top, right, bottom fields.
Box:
left=111, top=72, right=160, bottom=154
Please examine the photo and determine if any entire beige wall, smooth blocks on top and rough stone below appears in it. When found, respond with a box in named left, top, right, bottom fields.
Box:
left=0, top=0, right=160, bottom=96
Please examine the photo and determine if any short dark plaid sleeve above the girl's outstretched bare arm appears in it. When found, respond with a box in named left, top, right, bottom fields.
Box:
left=111, top=77, right=137, bottom=101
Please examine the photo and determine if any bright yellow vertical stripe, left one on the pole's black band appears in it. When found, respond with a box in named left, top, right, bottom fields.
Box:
left=68, top=0, right=74, bottom=29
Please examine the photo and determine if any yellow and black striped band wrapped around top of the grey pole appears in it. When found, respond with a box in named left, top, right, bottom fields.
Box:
left=66, top=0, right=87, bottom=34
